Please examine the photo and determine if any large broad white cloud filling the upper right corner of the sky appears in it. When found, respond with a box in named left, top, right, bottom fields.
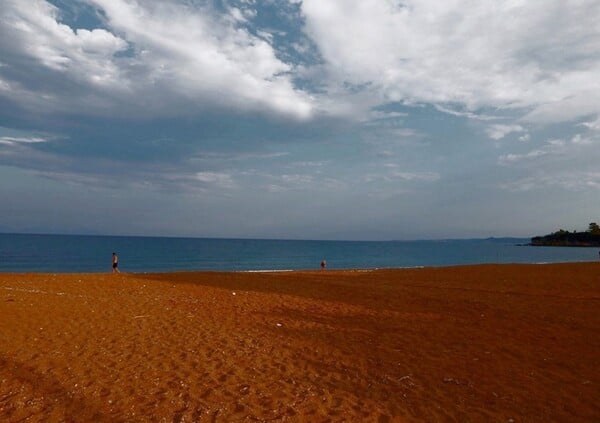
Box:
left=302, top=0, right=600, bottom=123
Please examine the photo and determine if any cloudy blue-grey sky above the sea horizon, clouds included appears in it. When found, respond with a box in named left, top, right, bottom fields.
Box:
left=0, top=0, right=600, bottom=240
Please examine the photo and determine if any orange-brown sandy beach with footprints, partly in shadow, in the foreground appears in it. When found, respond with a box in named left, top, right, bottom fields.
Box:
left=0, top=263, right=600, bottom=422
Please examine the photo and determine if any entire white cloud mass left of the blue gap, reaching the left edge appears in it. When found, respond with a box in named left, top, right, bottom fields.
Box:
left=0, top=0, right=313, bottom=119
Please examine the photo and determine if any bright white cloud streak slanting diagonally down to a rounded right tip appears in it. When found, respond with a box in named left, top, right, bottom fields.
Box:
left=90, top=0, right=312, bottom=118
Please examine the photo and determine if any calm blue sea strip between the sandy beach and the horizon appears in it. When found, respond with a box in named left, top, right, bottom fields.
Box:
left=0, top=234, right=598, bottom=272
